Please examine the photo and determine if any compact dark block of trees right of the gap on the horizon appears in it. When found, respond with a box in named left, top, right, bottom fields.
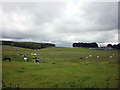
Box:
left=73, top=42, right=98, bottom=48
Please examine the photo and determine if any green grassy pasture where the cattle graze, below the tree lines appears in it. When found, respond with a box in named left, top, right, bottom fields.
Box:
left=2, top=46, right=120, bottom=88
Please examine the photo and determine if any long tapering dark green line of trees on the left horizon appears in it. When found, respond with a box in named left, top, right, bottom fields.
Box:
left=1, top=41, right=55, bottom=49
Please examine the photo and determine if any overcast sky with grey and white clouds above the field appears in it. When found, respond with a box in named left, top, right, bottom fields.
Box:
left=0, top=0, right=118, bottom=47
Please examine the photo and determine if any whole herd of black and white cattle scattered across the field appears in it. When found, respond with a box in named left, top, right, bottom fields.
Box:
left=3, top=53, right=115, bottom=64
